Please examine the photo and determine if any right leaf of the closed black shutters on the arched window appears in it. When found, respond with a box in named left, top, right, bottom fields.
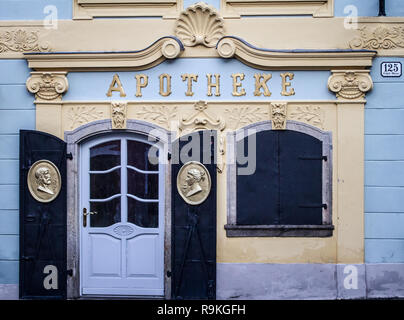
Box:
left=279, top=130, right=324, bottom=225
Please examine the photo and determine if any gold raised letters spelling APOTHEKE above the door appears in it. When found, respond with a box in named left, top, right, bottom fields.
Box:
left=106, top=72, right=295, bottom=97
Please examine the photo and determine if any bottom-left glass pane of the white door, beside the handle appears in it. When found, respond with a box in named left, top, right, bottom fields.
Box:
left=87, top=197, right=121, bottom=228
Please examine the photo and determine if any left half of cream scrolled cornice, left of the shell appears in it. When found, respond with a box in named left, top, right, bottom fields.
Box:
left=24, top=37, right=184, bottom=71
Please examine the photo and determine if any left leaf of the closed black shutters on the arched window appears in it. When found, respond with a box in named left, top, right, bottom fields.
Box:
left=236, top=130, right=279, bottom=225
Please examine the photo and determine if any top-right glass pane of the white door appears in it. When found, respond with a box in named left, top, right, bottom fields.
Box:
left=128, top=140, right=158, bottom=171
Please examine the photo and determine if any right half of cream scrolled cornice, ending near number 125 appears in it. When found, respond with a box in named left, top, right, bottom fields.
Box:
left=216, top=36, right=376, bottom=70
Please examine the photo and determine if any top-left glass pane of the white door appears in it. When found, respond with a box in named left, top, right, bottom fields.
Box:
left=90, top=140, right=121, bottom=171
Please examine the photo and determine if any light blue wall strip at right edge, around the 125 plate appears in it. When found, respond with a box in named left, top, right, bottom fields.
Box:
left=365, top=57, right=404, bottom=263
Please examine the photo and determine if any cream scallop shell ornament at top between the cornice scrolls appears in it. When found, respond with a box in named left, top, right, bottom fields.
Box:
left=175, top=2, right=224, bottom=47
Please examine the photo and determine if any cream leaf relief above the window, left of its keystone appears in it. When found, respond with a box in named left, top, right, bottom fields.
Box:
left=225, top=106, right=269, bottom=130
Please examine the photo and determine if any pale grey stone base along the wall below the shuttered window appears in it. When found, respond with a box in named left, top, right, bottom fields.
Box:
left=217, top=263, right=404, bottom=300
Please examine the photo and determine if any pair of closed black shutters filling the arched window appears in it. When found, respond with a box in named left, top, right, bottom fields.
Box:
left=237, top=130, right=326, bottom=225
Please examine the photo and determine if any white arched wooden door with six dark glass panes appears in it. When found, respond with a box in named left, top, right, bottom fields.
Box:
left=80, top=134, right=164, bottom=295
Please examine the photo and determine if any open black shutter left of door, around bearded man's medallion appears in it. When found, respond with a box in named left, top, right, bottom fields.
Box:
left=20, top=130, right=66, bottom=299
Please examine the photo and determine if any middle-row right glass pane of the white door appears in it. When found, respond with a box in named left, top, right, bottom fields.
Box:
left=128, top=169, right=159, bottom=199
